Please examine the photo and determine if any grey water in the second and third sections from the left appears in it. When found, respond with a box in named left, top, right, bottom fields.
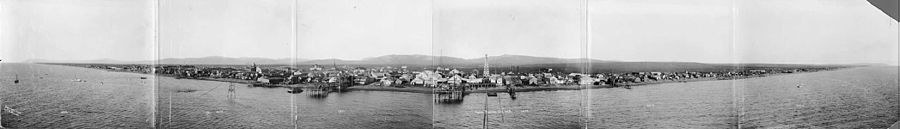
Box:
left=157, top=78, right=432, bottom=129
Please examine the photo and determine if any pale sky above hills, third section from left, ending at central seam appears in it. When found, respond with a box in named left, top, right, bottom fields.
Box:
left=295, top=0, right=432, bottom=59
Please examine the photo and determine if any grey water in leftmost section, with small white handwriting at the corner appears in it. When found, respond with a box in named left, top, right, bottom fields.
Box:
left=0, top=63, right=155, bottom=128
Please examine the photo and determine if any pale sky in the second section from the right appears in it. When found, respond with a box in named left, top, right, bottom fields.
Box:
left=589, top=0, right=734, bottom=63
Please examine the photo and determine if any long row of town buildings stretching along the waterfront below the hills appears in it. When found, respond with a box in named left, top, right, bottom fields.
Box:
left=67, top=61, right=832, bottom=87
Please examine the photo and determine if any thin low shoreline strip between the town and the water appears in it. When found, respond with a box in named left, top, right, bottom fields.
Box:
left=51, top=64, right=838, bottom=94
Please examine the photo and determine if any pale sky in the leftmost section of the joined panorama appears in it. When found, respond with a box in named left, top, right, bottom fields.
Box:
left=0, top=0, right=154, bottom=62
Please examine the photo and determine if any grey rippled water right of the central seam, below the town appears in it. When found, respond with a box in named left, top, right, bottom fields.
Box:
left=434, top=67, right=900, bottom=128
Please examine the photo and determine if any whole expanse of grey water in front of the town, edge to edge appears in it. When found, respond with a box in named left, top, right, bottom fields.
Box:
left=0, top=64, right=900, bottom=128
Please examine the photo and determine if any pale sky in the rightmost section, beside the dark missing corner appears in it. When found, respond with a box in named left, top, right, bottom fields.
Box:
left=735, top=0, right=900, bottom=65
